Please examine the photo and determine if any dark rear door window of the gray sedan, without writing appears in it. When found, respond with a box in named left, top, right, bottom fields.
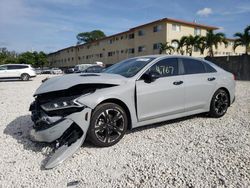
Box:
left=182, top=59, right=206, bottom=74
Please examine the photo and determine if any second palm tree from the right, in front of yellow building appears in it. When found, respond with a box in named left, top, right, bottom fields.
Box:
left=205, top=30, right=227, bottom=57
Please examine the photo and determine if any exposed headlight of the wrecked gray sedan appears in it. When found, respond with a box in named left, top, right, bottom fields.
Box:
left=41, top=96, right=84, bottom=111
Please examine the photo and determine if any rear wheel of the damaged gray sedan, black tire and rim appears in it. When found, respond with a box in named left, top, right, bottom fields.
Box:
left=209, top=89, right=230, bottom=118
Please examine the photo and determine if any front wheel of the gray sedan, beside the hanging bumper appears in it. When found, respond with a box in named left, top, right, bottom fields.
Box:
left=88, top=103, right=128, bottom=147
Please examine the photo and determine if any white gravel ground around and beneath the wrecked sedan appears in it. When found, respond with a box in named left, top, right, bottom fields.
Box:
left=0, top=76, right=250, bottom=188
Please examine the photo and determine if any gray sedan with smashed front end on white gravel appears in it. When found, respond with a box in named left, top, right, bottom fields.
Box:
left=30, top=55, right=235, bottom=168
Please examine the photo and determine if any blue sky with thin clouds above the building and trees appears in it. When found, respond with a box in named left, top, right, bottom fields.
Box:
left=0, top=0, right=250, bottom=52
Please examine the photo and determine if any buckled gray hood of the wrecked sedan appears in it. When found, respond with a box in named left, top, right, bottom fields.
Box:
left=34, top=73, right=127, bottom=96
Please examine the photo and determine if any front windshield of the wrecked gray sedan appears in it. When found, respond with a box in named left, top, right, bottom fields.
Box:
left=104, top=57, right=155, bottom=78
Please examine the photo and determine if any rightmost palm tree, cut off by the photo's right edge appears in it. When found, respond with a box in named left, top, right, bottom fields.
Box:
left=233, top=25, right=250, bottom=54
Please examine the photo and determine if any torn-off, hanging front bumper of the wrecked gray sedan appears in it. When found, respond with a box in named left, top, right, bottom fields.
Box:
left=30, top=102, right=92, bottom=169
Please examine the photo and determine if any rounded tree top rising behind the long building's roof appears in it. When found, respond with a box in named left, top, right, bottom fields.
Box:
left=76, top=30, right=106, bottom=44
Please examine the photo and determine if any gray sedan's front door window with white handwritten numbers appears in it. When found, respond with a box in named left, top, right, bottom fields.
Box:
left=147, top=58, right=178, bottom=77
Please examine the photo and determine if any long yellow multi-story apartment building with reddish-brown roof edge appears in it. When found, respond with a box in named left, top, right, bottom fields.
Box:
left=48, top=18, right=244, bottom=67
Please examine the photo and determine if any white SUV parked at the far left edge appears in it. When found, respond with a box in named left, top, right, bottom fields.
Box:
left=0, top=64, right=36, bottom=81
